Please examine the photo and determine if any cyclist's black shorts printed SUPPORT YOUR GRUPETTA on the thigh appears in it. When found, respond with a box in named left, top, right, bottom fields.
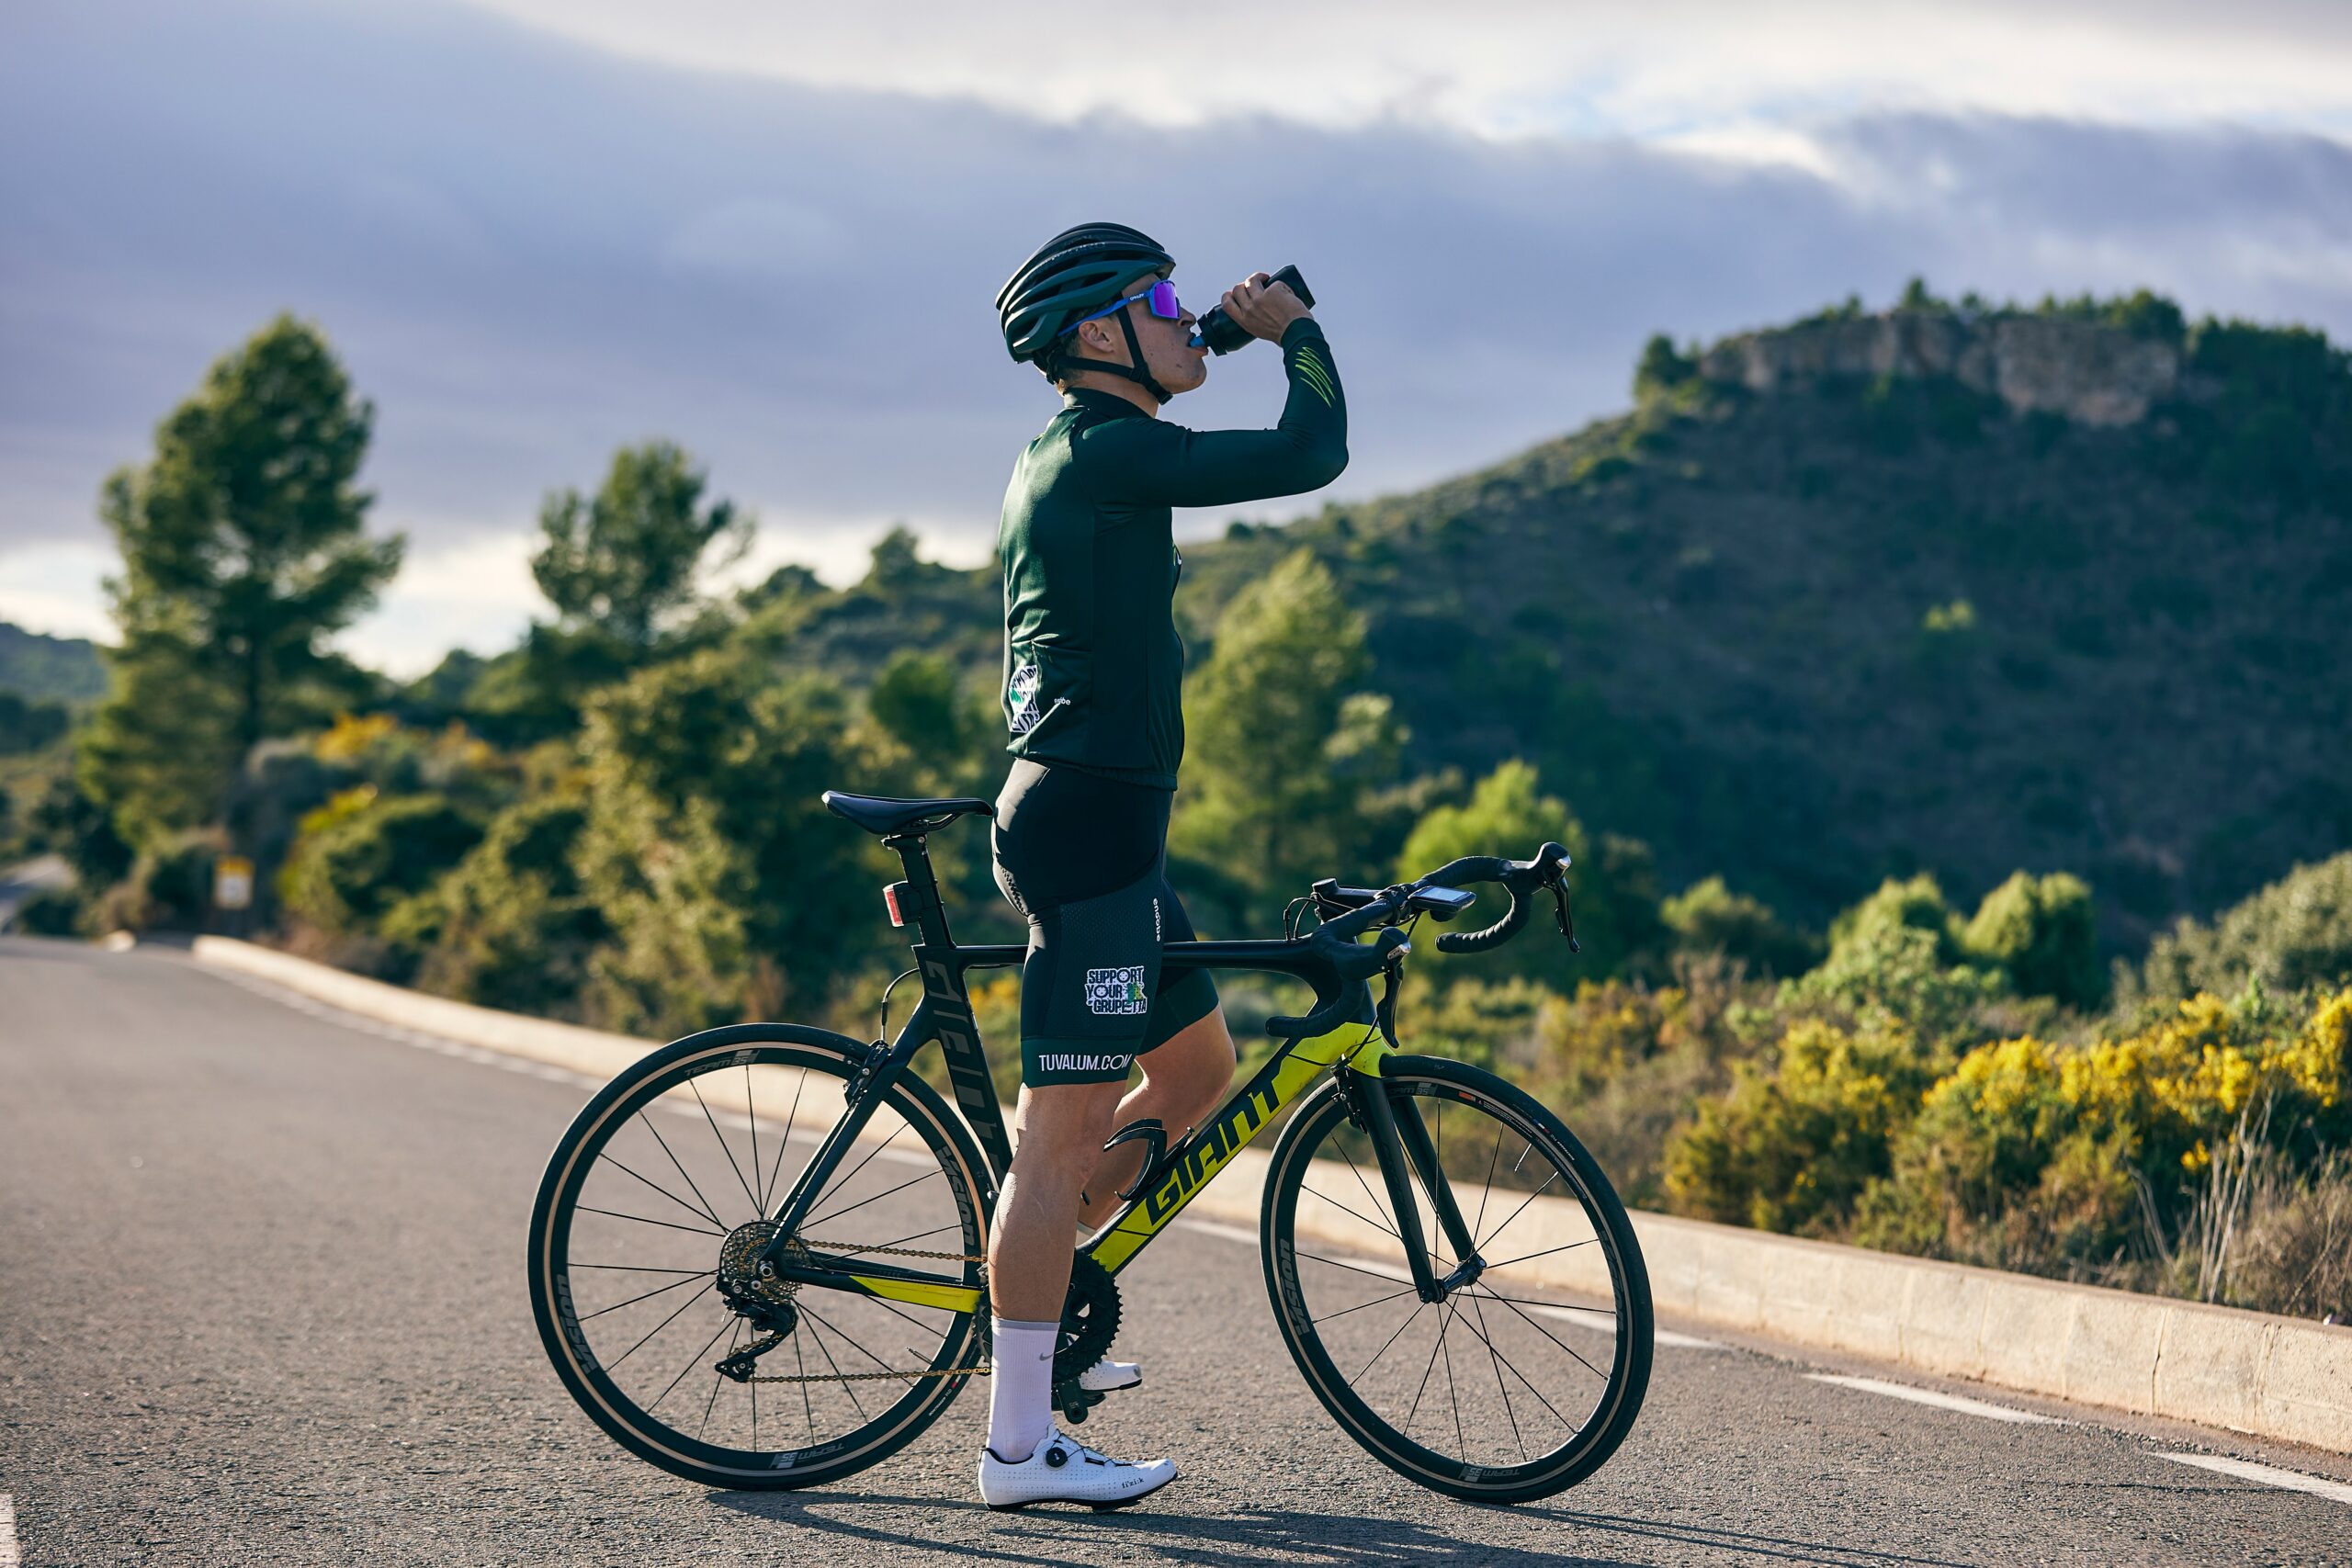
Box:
left=990, top=760, right=1216, bottom=1089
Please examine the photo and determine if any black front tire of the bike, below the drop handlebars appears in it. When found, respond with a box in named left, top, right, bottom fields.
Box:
left=1261, top=1055, right=1656, bottom=1502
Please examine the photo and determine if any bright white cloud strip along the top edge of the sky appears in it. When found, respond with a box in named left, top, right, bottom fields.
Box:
left=454, top=0, right=2352, bottom=136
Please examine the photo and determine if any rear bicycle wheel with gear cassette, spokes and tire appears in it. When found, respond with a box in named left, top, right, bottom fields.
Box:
left=529, top=1025, right=988, bottom=1488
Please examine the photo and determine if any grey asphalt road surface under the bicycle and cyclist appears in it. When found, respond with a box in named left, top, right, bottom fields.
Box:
left=0, top=938, right=2352, bottom=1565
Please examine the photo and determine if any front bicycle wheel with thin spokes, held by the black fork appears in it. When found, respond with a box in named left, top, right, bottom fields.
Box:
left=1263, top=1055, right=1654, bottom=1502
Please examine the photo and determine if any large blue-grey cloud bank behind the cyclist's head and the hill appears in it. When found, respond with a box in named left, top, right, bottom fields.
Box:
left=0, top=0, right=2352, bottom=668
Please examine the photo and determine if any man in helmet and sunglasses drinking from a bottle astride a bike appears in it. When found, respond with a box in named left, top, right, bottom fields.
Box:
left=981, top=223, right=1348, bottom=1506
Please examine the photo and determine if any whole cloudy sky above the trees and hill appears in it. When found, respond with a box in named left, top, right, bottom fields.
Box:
left=0, top=0, right=2352, bottom=672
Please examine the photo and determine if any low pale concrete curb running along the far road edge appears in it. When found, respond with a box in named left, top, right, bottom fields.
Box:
left=193, top=936, right=2352, bottom=1453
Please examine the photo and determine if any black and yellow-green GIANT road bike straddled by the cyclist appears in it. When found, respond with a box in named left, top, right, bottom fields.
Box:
left=529, top=792, right=1654, bottom=1502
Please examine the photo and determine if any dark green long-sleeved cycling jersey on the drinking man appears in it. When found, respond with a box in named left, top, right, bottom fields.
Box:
left=997, top=320, right=1348, bottom=790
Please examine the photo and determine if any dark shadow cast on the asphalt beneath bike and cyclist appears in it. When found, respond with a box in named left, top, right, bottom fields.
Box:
left=710, top=1493, right=1969, bottom=1568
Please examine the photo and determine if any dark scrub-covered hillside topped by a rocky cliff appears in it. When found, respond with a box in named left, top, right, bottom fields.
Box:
left=481, top=291, right=2352, bottom=945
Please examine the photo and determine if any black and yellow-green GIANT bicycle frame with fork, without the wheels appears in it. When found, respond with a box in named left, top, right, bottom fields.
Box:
left=762, top=835, right=1482, bottom=1312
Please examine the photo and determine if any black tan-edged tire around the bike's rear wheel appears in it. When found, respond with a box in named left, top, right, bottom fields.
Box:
left=529, top=1022, right=988, bottom=1491
